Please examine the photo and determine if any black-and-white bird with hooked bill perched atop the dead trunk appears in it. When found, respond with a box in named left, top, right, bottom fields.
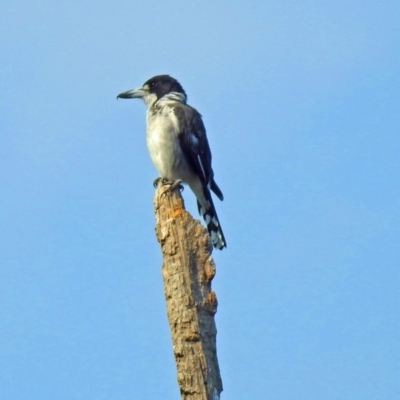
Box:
left=117, top=75, right=226, bottom=250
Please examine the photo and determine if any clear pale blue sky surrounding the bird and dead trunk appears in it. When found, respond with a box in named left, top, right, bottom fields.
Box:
left=0, top=0, right=400, bottom=400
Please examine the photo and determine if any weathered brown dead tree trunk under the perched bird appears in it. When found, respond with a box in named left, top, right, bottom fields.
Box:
left=154, top=183, right=222, bottom=400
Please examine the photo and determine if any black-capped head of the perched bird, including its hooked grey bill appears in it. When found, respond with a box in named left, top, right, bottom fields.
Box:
left=117, top=75, right=187, bottom=107
